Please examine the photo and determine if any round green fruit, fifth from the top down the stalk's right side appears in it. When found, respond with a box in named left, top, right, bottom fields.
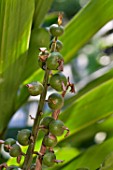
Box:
left=48, top=93, right=64, bottom=110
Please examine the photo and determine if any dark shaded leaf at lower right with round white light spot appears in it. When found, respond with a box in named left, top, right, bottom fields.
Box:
left=58, top=115, right=113, bottom=148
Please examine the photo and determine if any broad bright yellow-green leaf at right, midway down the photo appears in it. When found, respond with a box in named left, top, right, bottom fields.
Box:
left=61, top=79, right=113, bottom=137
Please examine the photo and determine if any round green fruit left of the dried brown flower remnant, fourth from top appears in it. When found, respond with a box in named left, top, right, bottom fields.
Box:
left=49, top=73, right=67, bottom=91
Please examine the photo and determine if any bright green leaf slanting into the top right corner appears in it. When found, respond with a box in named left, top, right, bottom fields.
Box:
left=61, top=0, right=113, bottom=62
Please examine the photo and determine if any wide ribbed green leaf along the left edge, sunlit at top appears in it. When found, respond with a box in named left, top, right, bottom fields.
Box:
left=0, top=0, right=34, bottom=134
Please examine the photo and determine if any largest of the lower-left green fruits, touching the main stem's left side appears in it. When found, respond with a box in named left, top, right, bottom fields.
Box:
left=17, top=129, right=31, bottom=146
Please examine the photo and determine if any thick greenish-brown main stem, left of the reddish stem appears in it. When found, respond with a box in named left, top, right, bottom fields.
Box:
left=23, top=70, right=50, bottom=170
